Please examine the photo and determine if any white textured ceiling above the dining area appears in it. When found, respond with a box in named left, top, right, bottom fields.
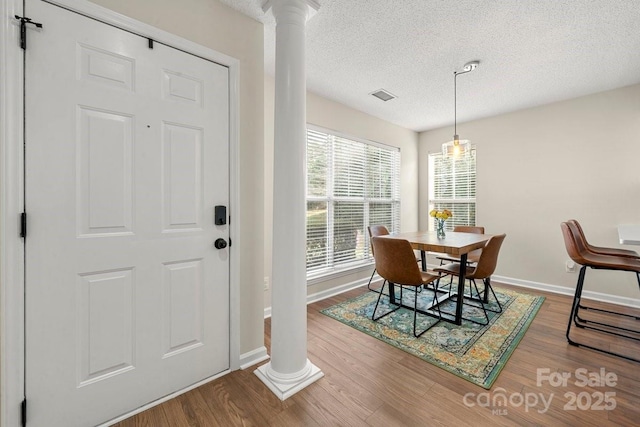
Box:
left=220, top=0, right=640, bottom=131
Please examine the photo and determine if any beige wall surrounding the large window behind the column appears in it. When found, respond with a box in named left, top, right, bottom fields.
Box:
left=264, top=76, right=418, bottom=307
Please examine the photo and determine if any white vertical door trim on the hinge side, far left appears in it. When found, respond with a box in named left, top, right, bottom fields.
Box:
left=0, top=0, right=24, bottom=426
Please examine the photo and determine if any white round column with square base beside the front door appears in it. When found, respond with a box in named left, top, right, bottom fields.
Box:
left=255, top=0, right=324, bottom=400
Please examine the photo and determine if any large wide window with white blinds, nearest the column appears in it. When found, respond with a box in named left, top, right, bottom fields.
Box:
left=307, top=127, right=400, bottom=276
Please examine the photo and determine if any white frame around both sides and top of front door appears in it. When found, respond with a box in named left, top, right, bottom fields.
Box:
left=0, top=0, right=240, bottom=426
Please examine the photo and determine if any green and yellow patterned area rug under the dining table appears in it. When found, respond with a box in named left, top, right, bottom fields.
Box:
left=322, top=287, right=544, bottom=389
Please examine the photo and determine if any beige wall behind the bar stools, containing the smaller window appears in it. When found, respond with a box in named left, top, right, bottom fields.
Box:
left=419, top=85, right=640, bottom=302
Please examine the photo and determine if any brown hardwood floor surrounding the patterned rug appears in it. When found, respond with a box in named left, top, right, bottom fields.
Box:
left=116, top=284, right=640, bottom=427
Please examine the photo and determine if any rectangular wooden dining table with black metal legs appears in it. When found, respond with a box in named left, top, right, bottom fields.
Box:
left=380, top=231, right=492, bottom=325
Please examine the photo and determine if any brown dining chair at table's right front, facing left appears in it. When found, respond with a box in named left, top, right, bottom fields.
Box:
left=433, top=234, right=507, bottom=325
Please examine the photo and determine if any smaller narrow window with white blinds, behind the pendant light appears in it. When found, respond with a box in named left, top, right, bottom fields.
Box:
left=429, top=147, right=476, bottom=230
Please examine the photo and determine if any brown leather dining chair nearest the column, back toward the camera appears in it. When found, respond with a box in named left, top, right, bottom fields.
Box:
left=371, top=237, right=442, bottom=338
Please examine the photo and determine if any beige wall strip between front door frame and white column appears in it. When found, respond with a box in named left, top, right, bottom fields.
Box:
left=92, top=0, right=264, bottom=354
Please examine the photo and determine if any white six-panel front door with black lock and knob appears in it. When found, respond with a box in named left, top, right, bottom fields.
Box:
left=25, top=0, right=229, bottom=427
